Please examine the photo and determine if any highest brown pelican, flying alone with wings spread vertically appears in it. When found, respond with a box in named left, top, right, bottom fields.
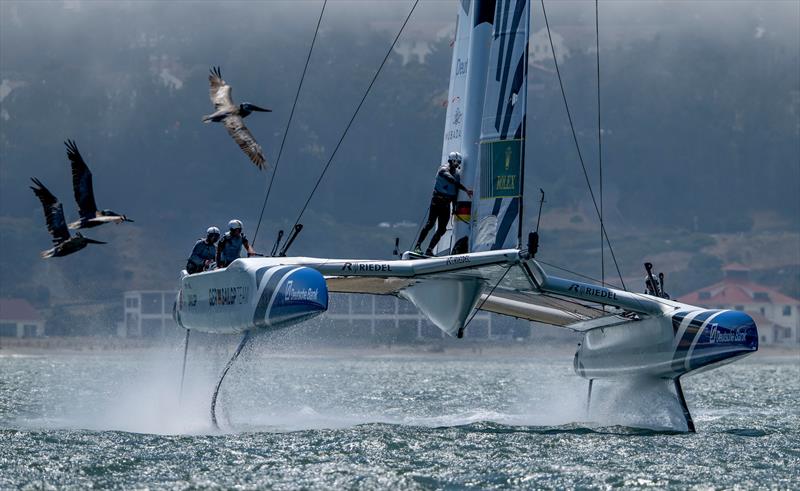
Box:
left=203, top=67, right=272, bottom=169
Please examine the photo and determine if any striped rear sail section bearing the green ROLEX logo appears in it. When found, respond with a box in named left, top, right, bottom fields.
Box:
left=470, top=0, right=530, bottom=251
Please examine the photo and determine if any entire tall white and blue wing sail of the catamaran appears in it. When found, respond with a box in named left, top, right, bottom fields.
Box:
left=436, top=0, right=530, bottom=255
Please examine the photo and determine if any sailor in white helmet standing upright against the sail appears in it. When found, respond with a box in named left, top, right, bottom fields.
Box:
left=414, top=152, right=472, bottom=256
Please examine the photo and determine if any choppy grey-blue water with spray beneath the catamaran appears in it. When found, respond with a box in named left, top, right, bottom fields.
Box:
left=0, top=346, right=800, bottom=489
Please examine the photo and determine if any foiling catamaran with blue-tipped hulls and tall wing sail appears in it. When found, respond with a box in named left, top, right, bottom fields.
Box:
left=175, top=0, right=758, bottom=431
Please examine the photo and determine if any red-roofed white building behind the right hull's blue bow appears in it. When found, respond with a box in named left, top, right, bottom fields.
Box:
left=678, top=264, right=800, bottom=346
